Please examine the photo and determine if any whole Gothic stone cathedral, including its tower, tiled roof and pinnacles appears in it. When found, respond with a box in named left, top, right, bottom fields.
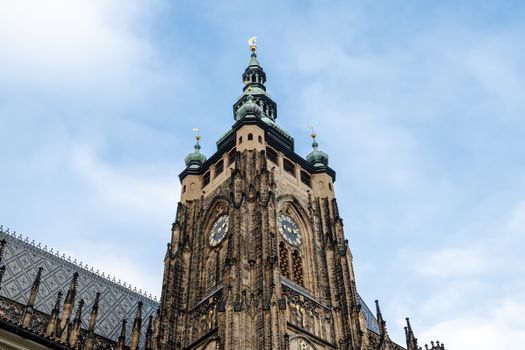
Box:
left=0, top=41, right=445, bottom=350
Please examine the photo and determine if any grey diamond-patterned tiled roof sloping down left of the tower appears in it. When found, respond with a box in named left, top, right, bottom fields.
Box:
left=0, top=227, right=159, bottom=348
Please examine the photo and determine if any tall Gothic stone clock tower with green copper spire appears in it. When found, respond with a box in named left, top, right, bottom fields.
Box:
left=154, top=40, right=369, bottom=350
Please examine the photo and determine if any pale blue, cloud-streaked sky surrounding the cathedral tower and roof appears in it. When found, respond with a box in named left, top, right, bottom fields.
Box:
left=0, top=0, right=525, bottom=349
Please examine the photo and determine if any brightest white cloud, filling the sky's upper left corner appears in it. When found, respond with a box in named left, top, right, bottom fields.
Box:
left=0, top=0, right=170, bottom=103
